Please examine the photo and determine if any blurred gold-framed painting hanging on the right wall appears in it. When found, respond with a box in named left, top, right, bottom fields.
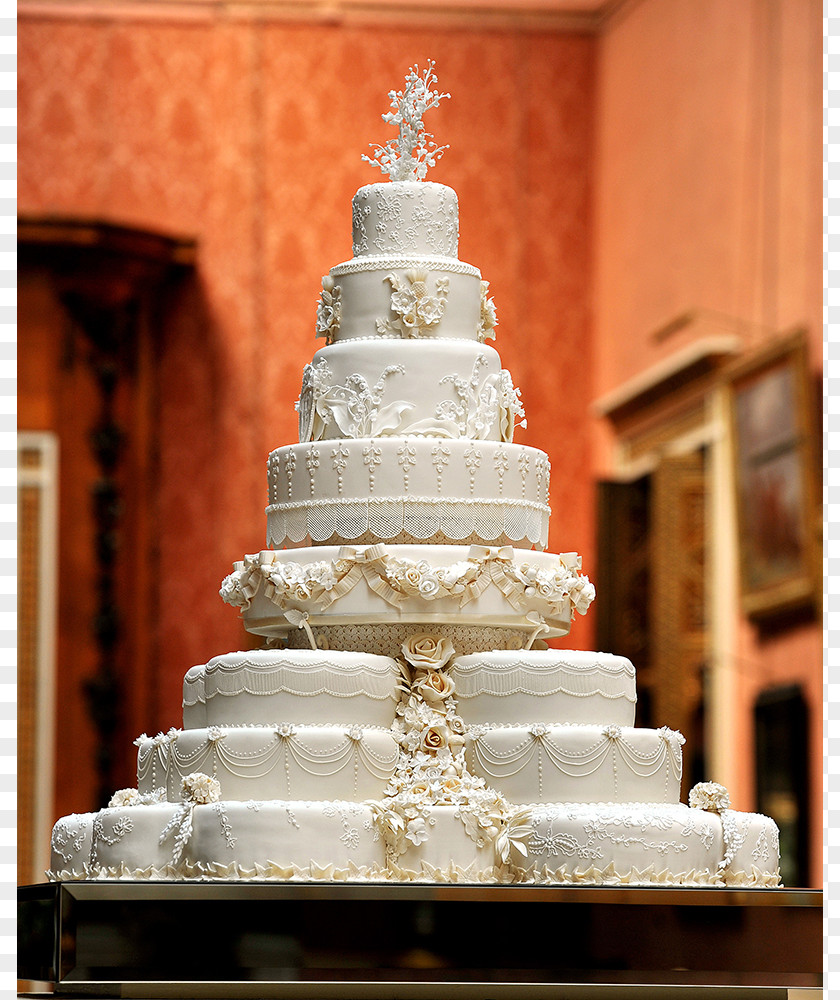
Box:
left=728, top=331, right=820, bottom=618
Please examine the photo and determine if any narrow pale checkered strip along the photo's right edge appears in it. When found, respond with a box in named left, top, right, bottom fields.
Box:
left=823, top=7, right=840, bottom=995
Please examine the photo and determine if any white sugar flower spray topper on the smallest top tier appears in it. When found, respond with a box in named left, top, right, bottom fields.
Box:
left=362, top=59, right=452, bottom=181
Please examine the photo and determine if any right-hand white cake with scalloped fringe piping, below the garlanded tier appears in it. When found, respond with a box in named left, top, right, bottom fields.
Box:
left=449, top=649, right=636, bottom=726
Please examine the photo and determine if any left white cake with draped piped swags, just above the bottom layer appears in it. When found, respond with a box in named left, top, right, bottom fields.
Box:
left=137, top=720, right=397, bottom=802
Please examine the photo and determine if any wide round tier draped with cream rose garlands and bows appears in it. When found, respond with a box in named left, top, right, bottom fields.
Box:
left=221, top=544, right=594, bottom=655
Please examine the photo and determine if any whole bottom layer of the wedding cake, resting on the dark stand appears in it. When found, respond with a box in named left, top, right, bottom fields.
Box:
left=47, top=797, right=779, bottom=887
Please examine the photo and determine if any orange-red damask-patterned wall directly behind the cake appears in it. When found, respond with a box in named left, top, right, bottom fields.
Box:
left=18, top=4, right=595, bottom=811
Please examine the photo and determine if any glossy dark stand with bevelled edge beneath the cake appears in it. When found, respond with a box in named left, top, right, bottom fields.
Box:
left=18, top=881, right=823, bottom=1000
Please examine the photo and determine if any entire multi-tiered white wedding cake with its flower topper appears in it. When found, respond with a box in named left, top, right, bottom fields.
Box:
left=49, top=64, right=779, bottom=886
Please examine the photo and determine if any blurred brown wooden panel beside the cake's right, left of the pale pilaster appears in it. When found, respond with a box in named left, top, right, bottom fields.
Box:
left=597, top=451, right=707, bottom=794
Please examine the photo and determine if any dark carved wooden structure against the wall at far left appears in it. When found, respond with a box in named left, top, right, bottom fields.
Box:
left=18, top=225, right=194, bottom=820
